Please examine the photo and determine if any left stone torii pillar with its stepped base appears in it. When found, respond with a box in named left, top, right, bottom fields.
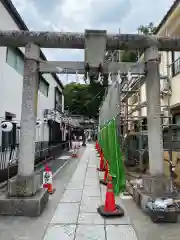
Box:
left=0, top=43, right=49, bottom=217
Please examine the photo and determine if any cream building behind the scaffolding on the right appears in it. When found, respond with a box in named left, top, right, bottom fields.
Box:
left=122, top=0, right=180, bottom=174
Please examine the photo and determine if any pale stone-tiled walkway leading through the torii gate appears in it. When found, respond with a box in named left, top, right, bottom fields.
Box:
left=44, top=144, right=137, bottom=240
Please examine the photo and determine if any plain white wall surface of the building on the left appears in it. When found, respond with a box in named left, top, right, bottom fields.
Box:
left=0, top=2, right=64, bottom=145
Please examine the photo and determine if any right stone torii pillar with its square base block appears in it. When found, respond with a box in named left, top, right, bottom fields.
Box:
left=143, top=47, right=172, bottom=196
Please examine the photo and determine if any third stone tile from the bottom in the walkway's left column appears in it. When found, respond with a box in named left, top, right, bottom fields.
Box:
left=60, top=189, right=82, bottom=203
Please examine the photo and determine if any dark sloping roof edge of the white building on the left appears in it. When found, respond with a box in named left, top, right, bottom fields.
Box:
left=0, top=0, right=64, bottom=89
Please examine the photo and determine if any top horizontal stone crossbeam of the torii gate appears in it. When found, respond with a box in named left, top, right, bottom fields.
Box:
left=0, top=30, right=180, bottom=51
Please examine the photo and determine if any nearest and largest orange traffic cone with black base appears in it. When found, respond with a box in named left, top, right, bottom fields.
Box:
left=97, top=176, right=124, bottom=217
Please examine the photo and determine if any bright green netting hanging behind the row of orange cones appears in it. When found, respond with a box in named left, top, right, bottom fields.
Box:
left=98, top=119, right=125, bottom=195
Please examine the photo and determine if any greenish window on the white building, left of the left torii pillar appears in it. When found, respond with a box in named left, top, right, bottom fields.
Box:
left=6, top=47, right=24, bottom=75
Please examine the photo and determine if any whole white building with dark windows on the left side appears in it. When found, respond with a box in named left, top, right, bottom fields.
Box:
left=0, top=0, right=64, bottom=157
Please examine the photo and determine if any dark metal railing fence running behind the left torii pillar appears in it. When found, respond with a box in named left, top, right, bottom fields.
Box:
left=0, top=141, right=69, bottom=182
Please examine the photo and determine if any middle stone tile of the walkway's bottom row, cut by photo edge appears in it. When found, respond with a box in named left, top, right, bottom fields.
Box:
left=75, top=225, right=105, bottom=240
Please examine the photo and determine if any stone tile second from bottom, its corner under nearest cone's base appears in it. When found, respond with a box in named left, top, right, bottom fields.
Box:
left=78, top=212, right=104, bottom=225
